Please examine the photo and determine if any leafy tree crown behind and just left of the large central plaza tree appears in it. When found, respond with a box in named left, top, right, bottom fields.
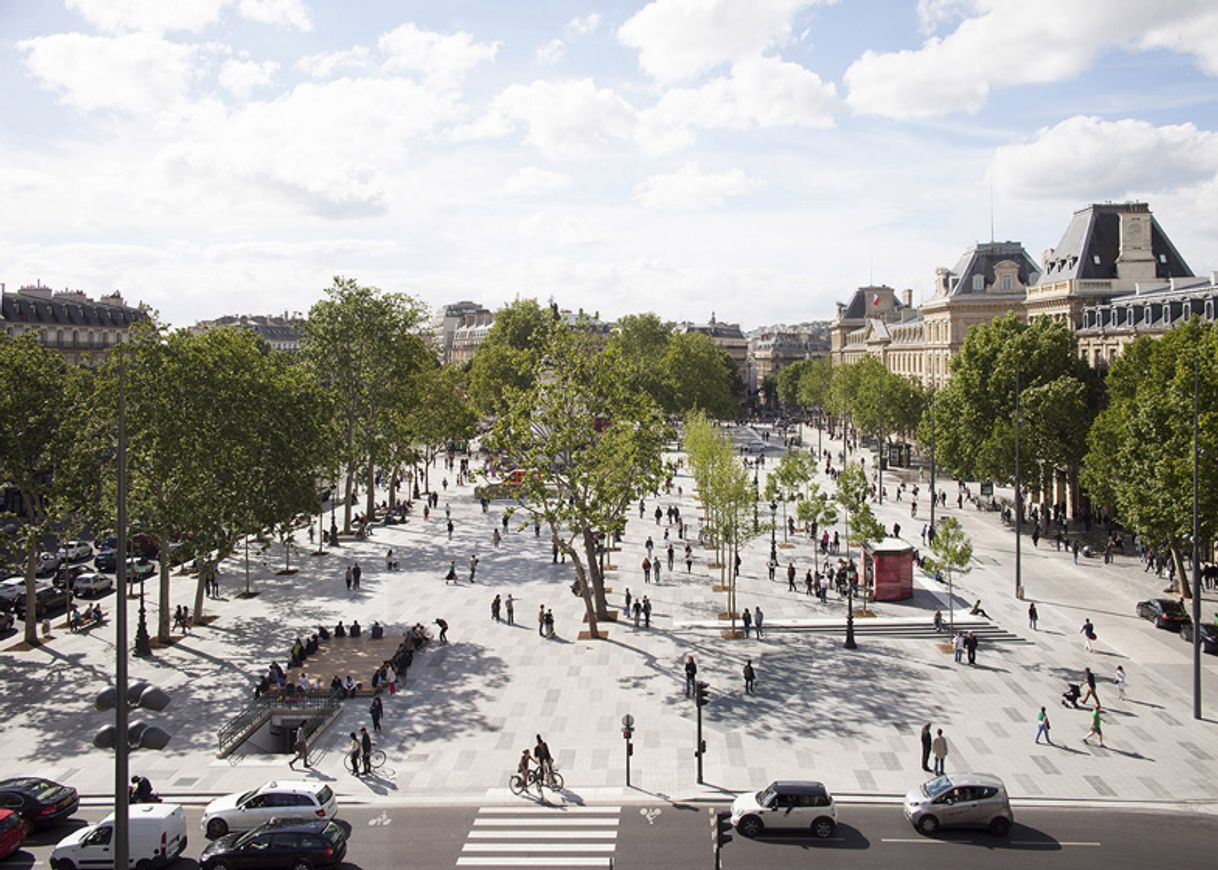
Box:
left=469, top=299, right=554, bottom=417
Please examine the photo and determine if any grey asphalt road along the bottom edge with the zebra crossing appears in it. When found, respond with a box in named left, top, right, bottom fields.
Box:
left=9, top=802, right=1218, bottom=870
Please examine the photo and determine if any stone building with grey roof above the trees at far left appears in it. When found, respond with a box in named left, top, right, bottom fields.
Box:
left=0, top=284, right=147, bottom=364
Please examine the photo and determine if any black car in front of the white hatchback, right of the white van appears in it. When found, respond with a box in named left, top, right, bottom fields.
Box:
left=199, top=819, right=347, bottom=870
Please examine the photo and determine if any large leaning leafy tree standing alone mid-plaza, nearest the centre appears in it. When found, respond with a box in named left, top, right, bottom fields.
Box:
left=487, top=329, right=666, bottom=637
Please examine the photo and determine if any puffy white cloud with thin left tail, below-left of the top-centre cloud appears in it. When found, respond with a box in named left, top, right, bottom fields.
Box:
left=479, top=78, right=638, bottom=157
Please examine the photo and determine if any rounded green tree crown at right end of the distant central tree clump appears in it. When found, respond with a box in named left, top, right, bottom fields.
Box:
left=663, top=333, right=744, bottom=420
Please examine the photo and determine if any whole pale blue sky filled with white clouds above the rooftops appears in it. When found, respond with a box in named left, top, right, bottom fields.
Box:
left=0, top=0, right=1218, bottom=328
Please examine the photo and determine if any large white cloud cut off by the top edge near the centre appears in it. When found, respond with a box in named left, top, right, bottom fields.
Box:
left=618, top=0, right=818, bottom=82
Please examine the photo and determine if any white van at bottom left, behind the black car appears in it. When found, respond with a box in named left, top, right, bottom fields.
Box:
left=51, top=803, right=186, bottom=870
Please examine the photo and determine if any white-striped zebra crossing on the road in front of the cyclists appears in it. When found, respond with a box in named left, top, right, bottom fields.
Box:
left=457, top=807, right=621, bottom=868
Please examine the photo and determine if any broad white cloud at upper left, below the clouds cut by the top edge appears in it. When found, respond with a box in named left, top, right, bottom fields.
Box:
left=17, top=33, right=197, bottom=113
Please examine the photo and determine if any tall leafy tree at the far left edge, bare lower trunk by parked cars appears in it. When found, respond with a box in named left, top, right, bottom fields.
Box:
left=0, top=333, right=68, bottom=645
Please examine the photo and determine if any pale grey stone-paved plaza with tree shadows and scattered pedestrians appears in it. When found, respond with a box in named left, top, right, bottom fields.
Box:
left=0, top=419, right=1218, bottom=803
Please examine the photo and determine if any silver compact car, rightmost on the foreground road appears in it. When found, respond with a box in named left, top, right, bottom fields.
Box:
left=904, top=774, right=1015, bottom=837
